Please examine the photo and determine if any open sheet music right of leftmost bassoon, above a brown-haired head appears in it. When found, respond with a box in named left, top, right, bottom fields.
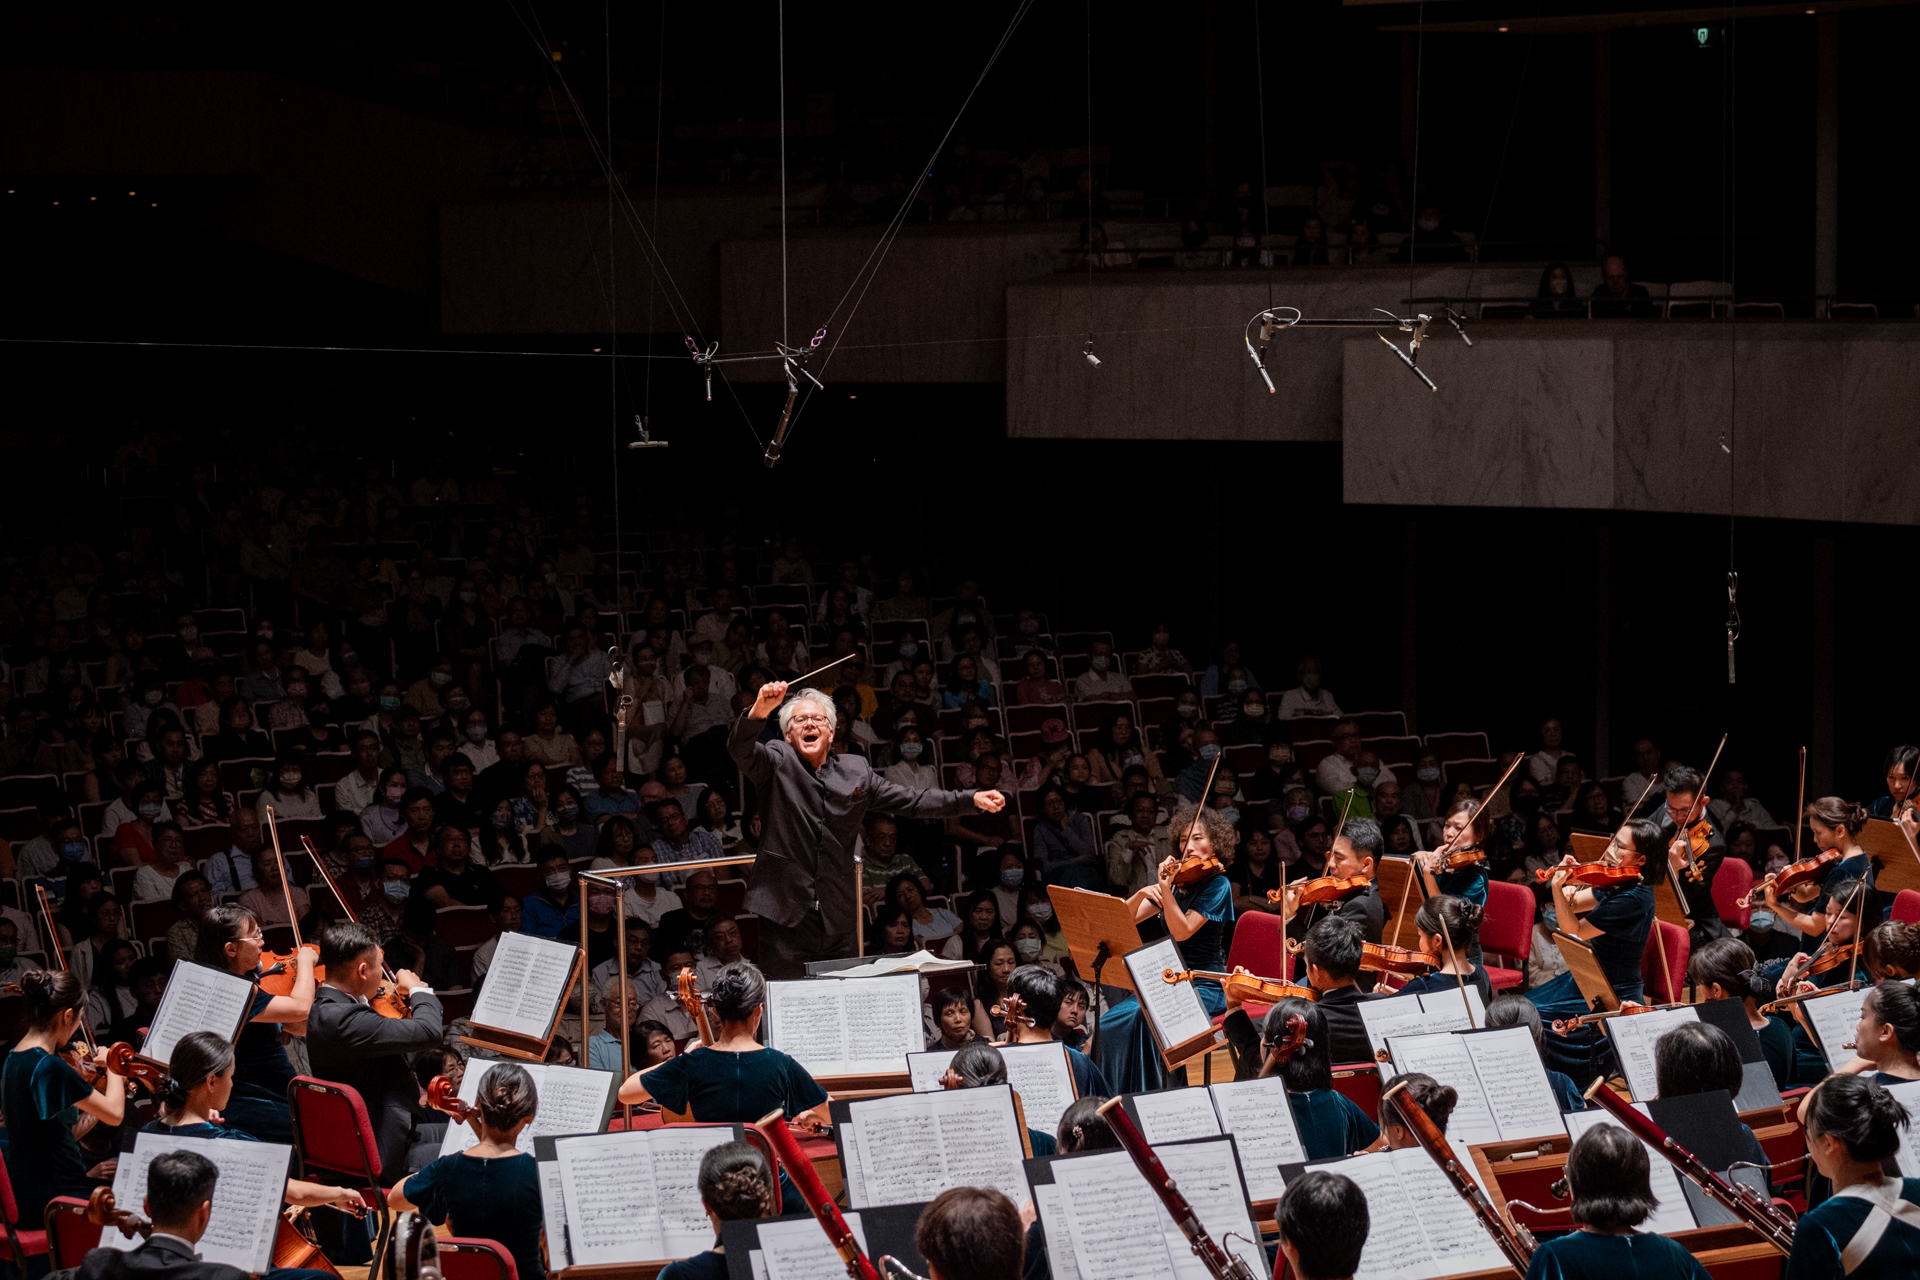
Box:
left=839, top=1084, right=1027, bottom=1209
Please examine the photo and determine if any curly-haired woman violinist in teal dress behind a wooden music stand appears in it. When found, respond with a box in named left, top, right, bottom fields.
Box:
left=1094, top=802, right=1240, bottom=1094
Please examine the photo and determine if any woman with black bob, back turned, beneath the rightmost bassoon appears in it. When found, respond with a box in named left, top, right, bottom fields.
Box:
left=1526, top=1125, right=1709, bottom=1280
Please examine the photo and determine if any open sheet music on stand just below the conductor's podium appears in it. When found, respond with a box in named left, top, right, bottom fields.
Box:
left=766, top=973, right=927, bottom=1080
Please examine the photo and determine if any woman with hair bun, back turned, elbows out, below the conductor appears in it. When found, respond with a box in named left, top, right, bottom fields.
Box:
left=620, top=960, right=829, bottom=1213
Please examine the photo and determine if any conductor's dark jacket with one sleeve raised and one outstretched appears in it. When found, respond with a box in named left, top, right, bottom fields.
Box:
left=728, top=714, right=973, bottom=938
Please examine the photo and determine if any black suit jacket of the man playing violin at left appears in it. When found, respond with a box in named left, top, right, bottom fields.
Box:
left=307, top=986, right=442, bottom=1182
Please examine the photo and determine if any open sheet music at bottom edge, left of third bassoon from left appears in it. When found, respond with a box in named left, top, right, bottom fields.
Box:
left=1313, top=1143, right=1524, bottom=1280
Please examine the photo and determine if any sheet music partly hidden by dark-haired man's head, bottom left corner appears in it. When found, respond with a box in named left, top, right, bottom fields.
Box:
left=100, top=1134, right=294, bottom=1274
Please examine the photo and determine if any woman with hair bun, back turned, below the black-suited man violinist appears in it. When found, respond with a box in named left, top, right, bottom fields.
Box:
left=386, top=1063, right=547, bottom=1280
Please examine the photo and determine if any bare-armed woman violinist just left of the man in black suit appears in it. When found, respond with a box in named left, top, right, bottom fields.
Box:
left=194, top=906, right=317, bottom=1144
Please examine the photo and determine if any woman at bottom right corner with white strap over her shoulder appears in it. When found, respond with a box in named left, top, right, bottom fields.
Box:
left=1786, top=1075, right=1920, bottom=1280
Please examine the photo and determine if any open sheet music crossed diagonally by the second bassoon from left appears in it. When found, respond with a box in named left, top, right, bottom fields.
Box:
left=1027, top=1138, right=1273, bottom=1280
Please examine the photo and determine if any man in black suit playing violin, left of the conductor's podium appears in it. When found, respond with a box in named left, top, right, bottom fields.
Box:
left=307, top=921, right=442, bottom=1182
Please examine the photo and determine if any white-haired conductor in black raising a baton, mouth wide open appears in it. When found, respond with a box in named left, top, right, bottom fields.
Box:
left=728, top=679, right=1006, bottom=979
